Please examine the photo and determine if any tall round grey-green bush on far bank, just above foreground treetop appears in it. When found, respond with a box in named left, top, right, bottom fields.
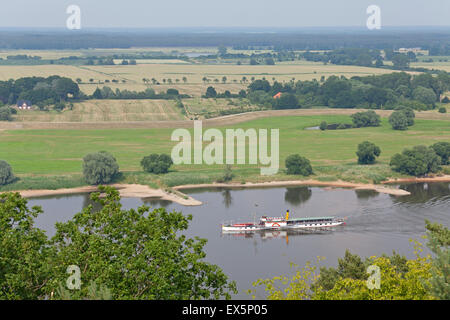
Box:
left=83, top=151, right=119, bottom=185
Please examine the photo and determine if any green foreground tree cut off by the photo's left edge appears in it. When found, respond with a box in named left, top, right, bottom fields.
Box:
left=0, top=193, right=51, bottom=300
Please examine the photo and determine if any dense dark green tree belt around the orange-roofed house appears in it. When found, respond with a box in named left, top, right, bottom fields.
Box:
left=248, top=72, right=450, bottom=110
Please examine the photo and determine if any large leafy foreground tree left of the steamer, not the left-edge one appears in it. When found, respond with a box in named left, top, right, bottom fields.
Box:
left=52, top=187, right=236, bottom=300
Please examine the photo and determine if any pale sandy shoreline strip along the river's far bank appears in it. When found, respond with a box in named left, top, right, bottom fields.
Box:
left=7, top=175, right=450, bottom=206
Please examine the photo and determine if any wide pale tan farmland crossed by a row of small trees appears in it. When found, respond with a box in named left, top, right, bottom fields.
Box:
left=0, top=60, right=391, bottom=96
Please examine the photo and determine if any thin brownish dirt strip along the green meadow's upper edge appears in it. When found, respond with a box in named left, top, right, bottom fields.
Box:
left=0, top=109, right=450, bottom=130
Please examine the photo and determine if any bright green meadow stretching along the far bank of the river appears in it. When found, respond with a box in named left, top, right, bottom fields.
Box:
left=0, top=115, right=450, bottom=190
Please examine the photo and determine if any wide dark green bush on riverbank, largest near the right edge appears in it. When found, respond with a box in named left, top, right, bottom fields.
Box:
left=390, top=146, right=441, bottom=177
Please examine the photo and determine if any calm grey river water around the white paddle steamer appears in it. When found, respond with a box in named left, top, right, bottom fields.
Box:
left=29, top=183, right=450, bottom=299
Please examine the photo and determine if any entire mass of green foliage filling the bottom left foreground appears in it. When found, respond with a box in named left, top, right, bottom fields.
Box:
left=0, top=187, right=236, bottom=299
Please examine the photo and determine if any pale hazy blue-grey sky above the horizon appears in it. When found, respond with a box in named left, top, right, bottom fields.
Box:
left=0, top=0, right=450, bottom=28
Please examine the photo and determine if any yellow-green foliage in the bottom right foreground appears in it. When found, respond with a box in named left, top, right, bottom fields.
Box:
left=248, top=221, right=450, bottom=300
